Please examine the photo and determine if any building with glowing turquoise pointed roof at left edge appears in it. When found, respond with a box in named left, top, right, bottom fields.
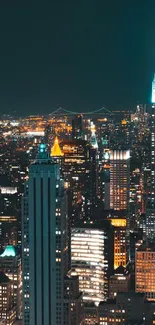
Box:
left=0, top=245, right=22, bottom=319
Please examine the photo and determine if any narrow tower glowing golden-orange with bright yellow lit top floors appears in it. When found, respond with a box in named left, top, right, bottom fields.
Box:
left=109, top=217, right=127, bottom=269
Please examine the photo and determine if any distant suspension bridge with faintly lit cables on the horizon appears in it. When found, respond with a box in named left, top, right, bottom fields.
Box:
left=49, top=107, right=112, bottom=116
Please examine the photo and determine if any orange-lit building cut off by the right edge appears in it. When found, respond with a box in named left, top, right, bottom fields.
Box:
left=135, top=242, right=155, bottom=301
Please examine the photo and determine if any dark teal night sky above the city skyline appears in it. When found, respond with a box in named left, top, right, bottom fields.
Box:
left=0, top=0, right=155, bottom=115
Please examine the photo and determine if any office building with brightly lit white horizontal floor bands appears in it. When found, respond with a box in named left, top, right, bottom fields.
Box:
left=71, top=221, right=113, bottom=303
